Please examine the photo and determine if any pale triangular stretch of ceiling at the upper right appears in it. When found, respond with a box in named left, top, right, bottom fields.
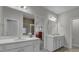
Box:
left=44, top=6, right=78, bottom=14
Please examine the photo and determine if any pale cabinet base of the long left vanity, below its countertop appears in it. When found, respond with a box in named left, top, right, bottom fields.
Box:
left=0, top=39, right=40, bottom=52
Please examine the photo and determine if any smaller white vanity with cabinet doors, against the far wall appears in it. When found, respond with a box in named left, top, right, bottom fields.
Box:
left=47, top=36, right=64, bottom=51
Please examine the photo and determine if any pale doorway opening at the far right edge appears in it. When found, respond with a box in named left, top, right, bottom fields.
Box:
left=72, top=19, right=79, bottom=47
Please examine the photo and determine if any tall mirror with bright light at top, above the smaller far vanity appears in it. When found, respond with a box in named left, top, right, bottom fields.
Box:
left=47, top=16, right=58, bottom=35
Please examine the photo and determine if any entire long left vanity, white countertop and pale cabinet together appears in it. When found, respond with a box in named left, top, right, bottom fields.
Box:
left=0, top=37, right=40, bottom=52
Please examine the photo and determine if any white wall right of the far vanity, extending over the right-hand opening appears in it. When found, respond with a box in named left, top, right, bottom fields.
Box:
left=58, top=8, right=79, bottom=48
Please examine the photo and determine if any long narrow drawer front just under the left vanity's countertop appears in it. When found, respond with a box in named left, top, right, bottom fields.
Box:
left=5, top=42, right=33, bottom=49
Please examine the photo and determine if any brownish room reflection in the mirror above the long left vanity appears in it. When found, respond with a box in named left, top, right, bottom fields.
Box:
left=23, top=17, right=34, bottom=35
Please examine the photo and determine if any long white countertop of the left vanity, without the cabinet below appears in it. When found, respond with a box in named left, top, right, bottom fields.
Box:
left=0, top=36, right=39, bottom=44
